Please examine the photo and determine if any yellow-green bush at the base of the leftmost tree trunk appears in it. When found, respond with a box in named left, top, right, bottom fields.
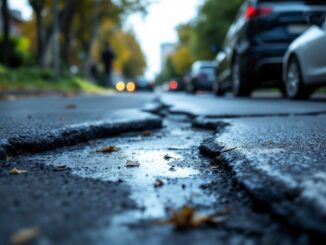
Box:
left=0, top=36, right=31, bottom=68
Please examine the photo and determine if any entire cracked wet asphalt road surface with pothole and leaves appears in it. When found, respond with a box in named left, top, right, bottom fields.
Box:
left=0, top=93, right=326, bottom=244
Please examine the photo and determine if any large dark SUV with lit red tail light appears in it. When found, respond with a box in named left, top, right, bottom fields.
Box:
left=213, top=0, right=326, bottom=96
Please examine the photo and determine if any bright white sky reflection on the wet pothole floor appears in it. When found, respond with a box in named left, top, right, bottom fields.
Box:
left=120, top=150, right=199, bottom=218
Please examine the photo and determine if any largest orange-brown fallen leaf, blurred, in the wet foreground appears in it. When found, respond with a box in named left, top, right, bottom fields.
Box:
left=161, top=206, right=226, bottom=230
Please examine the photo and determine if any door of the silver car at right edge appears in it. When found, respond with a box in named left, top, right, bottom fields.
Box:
left=304, top=21, right=326, bottom=83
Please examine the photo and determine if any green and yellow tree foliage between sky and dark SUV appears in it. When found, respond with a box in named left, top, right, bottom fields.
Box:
left=157, top=0, right=243, bottom=81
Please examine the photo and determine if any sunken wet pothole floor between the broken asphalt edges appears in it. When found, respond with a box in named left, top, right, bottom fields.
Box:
left=0, top=108, right=319, bottom=244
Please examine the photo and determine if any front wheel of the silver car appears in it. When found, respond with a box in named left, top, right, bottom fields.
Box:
left=285, top=57, right=312, bottom=99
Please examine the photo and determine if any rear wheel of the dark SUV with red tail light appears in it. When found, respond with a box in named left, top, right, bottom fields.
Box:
left=232, top=57, right=252, bottom=96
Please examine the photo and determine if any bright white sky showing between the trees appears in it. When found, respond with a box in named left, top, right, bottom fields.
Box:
left=9, top=0, right=202, bottom=78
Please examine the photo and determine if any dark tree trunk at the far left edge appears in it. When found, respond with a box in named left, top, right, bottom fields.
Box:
left=1, top=0, right=10, bottom=64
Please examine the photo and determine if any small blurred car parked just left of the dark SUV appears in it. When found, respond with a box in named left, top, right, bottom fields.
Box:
left=185, top=60, right=215, bottom=93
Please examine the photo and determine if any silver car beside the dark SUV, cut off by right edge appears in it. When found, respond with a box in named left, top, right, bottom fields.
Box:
left=283, top=18, right=326, bottom=99
